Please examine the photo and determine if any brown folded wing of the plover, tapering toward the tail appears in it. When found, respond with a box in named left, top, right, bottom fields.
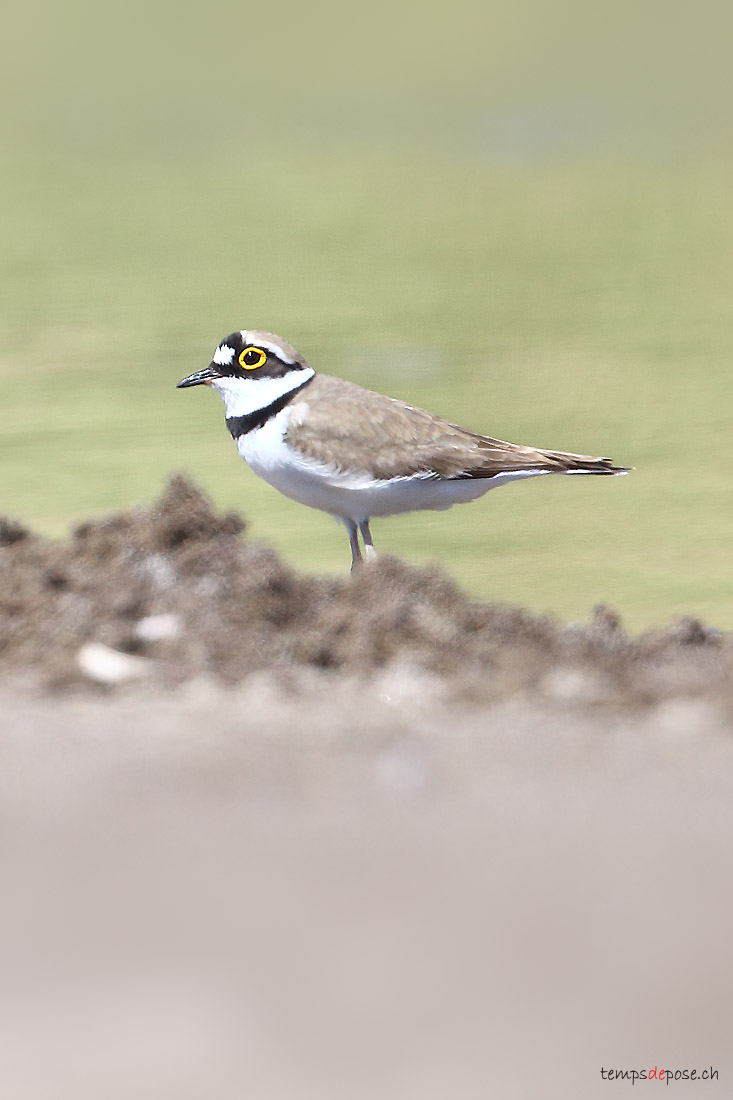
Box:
left=286, top=374, right=623, bottom=481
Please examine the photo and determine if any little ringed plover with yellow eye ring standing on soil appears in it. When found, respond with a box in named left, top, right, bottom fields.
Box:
left=178, top=329, right=628, bottom=569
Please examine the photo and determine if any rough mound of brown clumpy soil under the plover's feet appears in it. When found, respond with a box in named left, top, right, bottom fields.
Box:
left=0, top=476, right=733, bottom=705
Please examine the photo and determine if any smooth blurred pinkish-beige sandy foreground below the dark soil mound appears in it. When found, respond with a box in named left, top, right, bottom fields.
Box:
left=0, top=675, right=733, bottom=1100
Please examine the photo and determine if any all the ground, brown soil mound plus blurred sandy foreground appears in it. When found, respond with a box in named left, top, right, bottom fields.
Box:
left=0, top=479, right=733, bottom=1100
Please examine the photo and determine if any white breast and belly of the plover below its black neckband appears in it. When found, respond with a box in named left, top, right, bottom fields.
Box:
left=237, top=408, right=546, bottom=523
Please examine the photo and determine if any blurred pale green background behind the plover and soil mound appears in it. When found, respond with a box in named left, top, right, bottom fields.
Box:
left=0, top=0, right=733, bottom=628
